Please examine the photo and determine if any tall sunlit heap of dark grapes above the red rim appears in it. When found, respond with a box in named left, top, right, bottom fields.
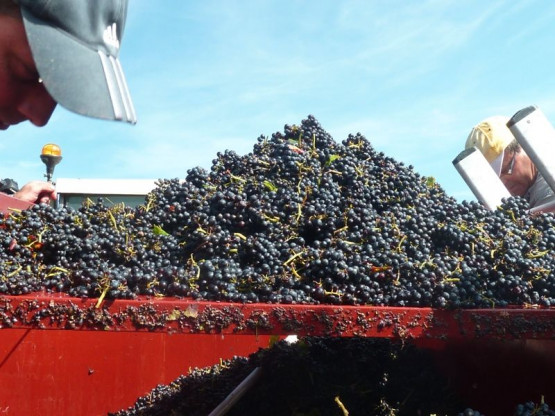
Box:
left=0, top=116, right=555, bottom=308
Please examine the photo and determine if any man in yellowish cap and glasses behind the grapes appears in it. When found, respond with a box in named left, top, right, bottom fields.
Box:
left=465, top=116, right=555, bottom=208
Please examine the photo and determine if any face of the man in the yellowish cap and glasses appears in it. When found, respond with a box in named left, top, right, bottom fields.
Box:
left=499, top=150, right=536, bottom=196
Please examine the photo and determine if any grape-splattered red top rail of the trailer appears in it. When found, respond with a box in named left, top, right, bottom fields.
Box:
left=0, top=294, right=555, bottom=340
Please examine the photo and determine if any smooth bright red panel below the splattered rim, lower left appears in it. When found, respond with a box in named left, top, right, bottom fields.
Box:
left=0, top=329, right=276, bottom=416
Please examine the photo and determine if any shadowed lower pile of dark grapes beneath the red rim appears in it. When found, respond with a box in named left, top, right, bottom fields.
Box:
left=108, top=337, right=555, bottom=416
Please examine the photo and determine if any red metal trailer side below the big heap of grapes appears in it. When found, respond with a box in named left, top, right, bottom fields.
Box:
left=0, top=195, right=555, bottom=415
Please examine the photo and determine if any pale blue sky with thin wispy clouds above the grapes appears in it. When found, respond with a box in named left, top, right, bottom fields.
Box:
left=0, top=0, right=555, bottom=200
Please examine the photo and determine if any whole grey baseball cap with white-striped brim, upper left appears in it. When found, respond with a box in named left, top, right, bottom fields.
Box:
left=16, top=0, right=137, bottom=124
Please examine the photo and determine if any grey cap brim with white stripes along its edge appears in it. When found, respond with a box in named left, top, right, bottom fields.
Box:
left=21, top=8, right=137, bottom=124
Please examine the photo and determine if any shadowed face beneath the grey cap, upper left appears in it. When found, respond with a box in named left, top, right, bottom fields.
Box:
left=0, top=10, right=56, bottom=130
